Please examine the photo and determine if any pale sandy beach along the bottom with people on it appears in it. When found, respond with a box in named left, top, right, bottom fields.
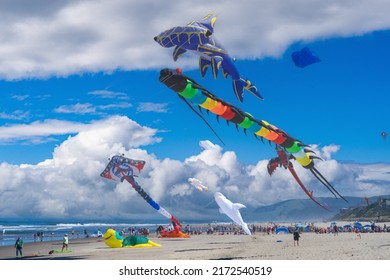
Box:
left=0, top=225, right=390, bottom=260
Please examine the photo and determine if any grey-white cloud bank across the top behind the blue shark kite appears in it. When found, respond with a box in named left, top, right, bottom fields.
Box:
left=0, top=0, right=390, bottom=79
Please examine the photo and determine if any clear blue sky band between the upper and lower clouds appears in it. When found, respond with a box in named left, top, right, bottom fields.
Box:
left=0, top=31, right=390, bottom=163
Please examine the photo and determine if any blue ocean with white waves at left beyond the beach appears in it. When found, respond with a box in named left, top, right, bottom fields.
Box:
left=0, top=219, right=167, bottom=246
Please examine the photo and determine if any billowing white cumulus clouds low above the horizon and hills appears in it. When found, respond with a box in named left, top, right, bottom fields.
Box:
left=0, top=116, right=390, bottom=220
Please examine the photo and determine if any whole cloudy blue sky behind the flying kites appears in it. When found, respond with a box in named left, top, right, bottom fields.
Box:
left=0, top=0, right=390, bottom=221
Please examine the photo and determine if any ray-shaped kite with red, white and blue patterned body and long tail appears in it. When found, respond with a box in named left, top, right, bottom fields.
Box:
left=100, top=156, right=181, bottom=227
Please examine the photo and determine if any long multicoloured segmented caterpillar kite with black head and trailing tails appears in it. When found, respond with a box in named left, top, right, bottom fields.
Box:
left=159, top=69, right=348, bottom=208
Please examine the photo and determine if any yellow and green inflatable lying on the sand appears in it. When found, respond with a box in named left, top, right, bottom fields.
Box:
left=104, top=228, right=161, bottom=248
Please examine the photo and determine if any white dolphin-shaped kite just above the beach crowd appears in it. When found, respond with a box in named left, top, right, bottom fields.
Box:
left=214, top=192, right=252, bottom=235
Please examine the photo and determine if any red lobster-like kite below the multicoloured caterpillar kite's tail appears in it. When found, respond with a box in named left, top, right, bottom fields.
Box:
left=267, top=145, right=329, bottom=210
